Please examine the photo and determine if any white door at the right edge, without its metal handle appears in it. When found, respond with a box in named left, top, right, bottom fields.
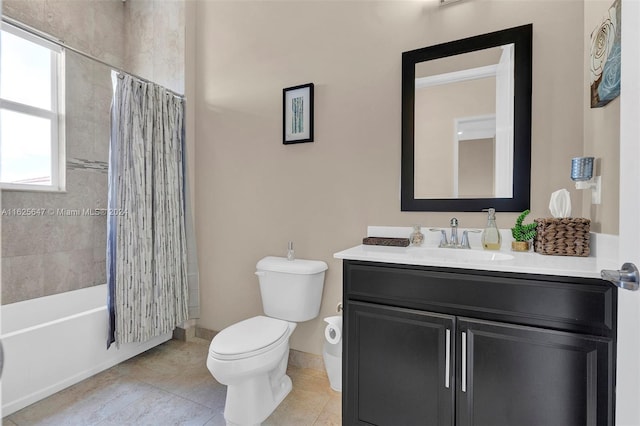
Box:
left=616, top=0, right=640, bottom=426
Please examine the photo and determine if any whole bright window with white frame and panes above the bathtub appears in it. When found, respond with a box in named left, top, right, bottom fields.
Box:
left=0, top=23, right=65, bottom=191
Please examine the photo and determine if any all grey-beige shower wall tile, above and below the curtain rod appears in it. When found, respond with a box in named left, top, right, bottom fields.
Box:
left=1, top=0, right=184, bottom=304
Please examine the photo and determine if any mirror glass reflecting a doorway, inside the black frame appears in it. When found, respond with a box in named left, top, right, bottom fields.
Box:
left=412, top=44, right=515, bottom=199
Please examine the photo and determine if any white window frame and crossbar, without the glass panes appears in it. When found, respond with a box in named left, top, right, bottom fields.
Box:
left=0, top=22, right=66, bottom=192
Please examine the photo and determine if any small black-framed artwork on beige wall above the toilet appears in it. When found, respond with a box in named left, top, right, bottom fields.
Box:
left=282, top=83, right=313, bottom=144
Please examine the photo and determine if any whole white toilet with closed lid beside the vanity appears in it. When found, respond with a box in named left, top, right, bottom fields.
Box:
left=207, top=256, right=327, bottom=426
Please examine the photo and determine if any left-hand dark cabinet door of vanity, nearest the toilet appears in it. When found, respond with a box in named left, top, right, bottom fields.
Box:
left=343, top=301, right=455, bottom=426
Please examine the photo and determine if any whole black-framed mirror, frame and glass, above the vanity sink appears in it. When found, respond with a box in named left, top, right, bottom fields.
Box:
left=401, top=24, right=533, bottom=212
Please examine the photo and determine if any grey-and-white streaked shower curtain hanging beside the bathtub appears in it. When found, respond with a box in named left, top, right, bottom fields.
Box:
left=107, top=73, right=189, bottom=346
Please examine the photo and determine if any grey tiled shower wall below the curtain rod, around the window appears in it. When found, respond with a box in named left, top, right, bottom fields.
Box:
left=2, top=52, right=111, bottom=304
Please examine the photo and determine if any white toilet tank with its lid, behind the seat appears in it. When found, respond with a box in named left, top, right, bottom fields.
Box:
left=256, top=256, right=328, bottom=322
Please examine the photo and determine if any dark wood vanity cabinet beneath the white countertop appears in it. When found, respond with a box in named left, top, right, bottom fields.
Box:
left=343, top=260, right=617, bottom=426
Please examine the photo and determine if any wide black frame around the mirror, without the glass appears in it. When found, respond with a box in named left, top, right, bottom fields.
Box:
left=400, top=24, right=533, bottom=212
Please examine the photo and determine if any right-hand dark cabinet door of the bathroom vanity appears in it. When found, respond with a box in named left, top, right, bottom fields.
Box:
left=456, top=318, right=614, bottom=426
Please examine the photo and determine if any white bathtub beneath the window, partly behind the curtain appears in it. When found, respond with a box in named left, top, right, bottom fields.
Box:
left=0, top=284, right=171, bottom=416
